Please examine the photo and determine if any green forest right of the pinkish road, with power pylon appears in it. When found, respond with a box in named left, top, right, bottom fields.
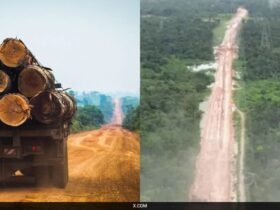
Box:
left=236, top=1, right=280, bottom=201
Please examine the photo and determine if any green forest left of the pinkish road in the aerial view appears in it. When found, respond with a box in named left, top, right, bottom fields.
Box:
left=140, top=0, right=223, bottom=201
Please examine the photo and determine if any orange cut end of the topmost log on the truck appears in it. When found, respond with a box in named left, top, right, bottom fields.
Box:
left=0, top=39, right=28, bottom=68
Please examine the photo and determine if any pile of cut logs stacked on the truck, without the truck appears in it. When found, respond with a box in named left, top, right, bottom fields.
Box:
left=0, top=38, right=76, bottom=127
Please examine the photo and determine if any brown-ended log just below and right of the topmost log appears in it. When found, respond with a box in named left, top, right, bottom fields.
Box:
left=18, top=65, right=55, bottom=97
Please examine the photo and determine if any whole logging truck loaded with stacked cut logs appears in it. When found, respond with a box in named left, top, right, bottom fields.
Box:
left=0, top=38, right=76, bottom=188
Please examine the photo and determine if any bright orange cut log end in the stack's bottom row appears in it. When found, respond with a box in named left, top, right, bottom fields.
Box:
left=0, top=94, right=30, bottom=127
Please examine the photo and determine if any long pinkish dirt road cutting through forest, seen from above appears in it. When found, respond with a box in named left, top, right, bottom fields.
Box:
left=189, top=8, right=247, bottom=202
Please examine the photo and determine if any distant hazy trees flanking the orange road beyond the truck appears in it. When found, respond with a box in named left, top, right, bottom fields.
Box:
left=69, top=90, right=140, bottom=133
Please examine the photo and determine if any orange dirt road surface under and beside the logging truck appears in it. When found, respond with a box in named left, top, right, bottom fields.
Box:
left=0, top=125, right=140, bottom=202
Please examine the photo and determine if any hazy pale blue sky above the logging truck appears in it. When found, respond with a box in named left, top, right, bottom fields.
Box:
left=0, top=0, right=140, bottom=93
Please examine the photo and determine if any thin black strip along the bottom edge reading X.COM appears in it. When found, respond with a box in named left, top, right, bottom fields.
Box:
left=0, top=202, right=280, bottom=210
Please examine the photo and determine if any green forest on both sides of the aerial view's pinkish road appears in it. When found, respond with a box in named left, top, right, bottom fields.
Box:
left=140, top=0, right=280, bottom=201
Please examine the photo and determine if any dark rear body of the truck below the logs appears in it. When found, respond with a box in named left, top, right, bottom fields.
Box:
left=0, top=120, right=70, bottom=188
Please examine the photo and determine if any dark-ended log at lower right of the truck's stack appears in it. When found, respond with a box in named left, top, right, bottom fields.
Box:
left=30, top=91, right=76, bottom=124
